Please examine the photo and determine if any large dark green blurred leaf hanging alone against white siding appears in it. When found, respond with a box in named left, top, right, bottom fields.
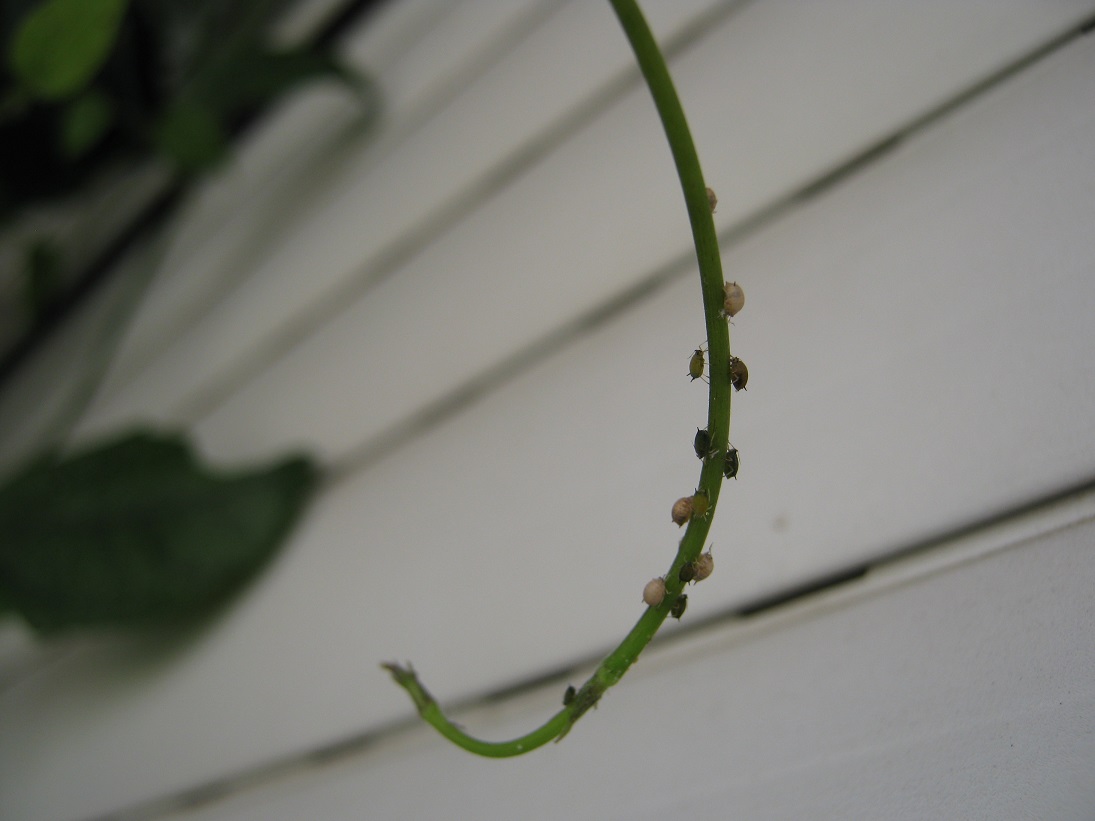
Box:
left=0, top=432, right=316, bottom=632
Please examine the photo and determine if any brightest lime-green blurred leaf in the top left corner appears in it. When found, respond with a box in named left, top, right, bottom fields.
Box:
left=8, top=0, right=126, bottom=100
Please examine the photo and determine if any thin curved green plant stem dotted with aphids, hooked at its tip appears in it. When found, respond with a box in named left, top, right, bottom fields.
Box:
left=383, top=0, right=730, bottom=758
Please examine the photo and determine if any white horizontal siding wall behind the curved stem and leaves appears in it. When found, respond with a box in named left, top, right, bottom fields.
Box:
left=0, top=0, right=1095, bottom=820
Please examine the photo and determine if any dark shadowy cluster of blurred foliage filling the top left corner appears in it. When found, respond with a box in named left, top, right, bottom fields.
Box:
left=0, top=0, right=377, bottom=215
